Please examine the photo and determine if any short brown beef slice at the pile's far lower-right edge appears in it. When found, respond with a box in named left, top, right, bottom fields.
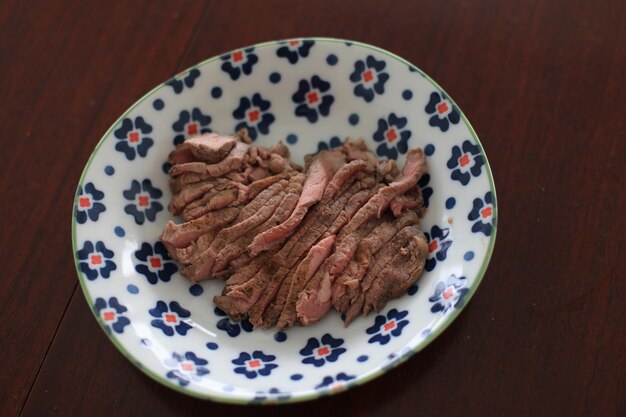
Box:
left=363, top=226, right=428, bottom=315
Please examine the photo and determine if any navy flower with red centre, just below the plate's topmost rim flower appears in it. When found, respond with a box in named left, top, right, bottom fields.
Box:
left=291, top=75, right=335, bottom=123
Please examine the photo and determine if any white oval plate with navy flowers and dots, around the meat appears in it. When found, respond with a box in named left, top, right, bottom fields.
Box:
left=72, top=38, right=497, bottom=403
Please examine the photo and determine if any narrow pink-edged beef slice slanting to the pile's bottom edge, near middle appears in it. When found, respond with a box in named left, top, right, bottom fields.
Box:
left=262, top=235, right=335, bottom=329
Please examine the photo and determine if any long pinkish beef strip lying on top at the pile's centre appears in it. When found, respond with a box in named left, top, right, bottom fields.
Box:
left=248, top=151, right=345, bottom=256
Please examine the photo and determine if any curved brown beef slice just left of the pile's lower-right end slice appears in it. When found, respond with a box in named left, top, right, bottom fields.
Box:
left=332, top=211, right=419, bottom=314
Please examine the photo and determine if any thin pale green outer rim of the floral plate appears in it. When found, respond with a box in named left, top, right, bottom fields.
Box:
left=71, top=36, right=498, bottom=405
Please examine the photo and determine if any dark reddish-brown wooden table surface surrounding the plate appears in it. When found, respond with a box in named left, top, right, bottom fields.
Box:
left=0, top=0, right=626, bottom=417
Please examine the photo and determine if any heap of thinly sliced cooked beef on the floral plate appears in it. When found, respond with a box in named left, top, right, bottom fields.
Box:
left=161, top=130, right=428, bottom=329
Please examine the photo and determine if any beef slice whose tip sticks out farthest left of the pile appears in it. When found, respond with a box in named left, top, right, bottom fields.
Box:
left=161, top=207, right=239, bottom=248
